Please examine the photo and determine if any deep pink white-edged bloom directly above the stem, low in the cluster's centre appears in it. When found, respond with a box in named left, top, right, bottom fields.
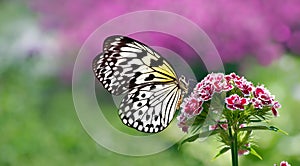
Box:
left=225, top=94, right=249, bottom=110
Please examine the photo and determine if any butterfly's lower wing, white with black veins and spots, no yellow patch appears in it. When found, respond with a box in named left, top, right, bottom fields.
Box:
left=119, top=84, right=181, bottom=133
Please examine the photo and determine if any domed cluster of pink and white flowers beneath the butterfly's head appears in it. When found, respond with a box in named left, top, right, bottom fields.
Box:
left=178, top=73, right=281, bottom=132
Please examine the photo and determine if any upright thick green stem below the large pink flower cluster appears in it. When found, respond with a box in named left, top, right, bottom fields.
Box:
left=229, top=127, right=239, bottom=166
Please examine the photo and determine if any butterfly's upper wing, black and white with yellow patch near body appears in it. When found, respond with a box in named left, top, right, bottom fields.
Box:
left=93, top=36, right=177, bottom=95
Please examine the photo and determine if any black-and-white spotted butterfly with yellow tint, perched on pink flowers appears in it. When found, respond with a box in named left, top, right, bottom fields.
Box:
left=92, top=36, right=188, bottom=133
